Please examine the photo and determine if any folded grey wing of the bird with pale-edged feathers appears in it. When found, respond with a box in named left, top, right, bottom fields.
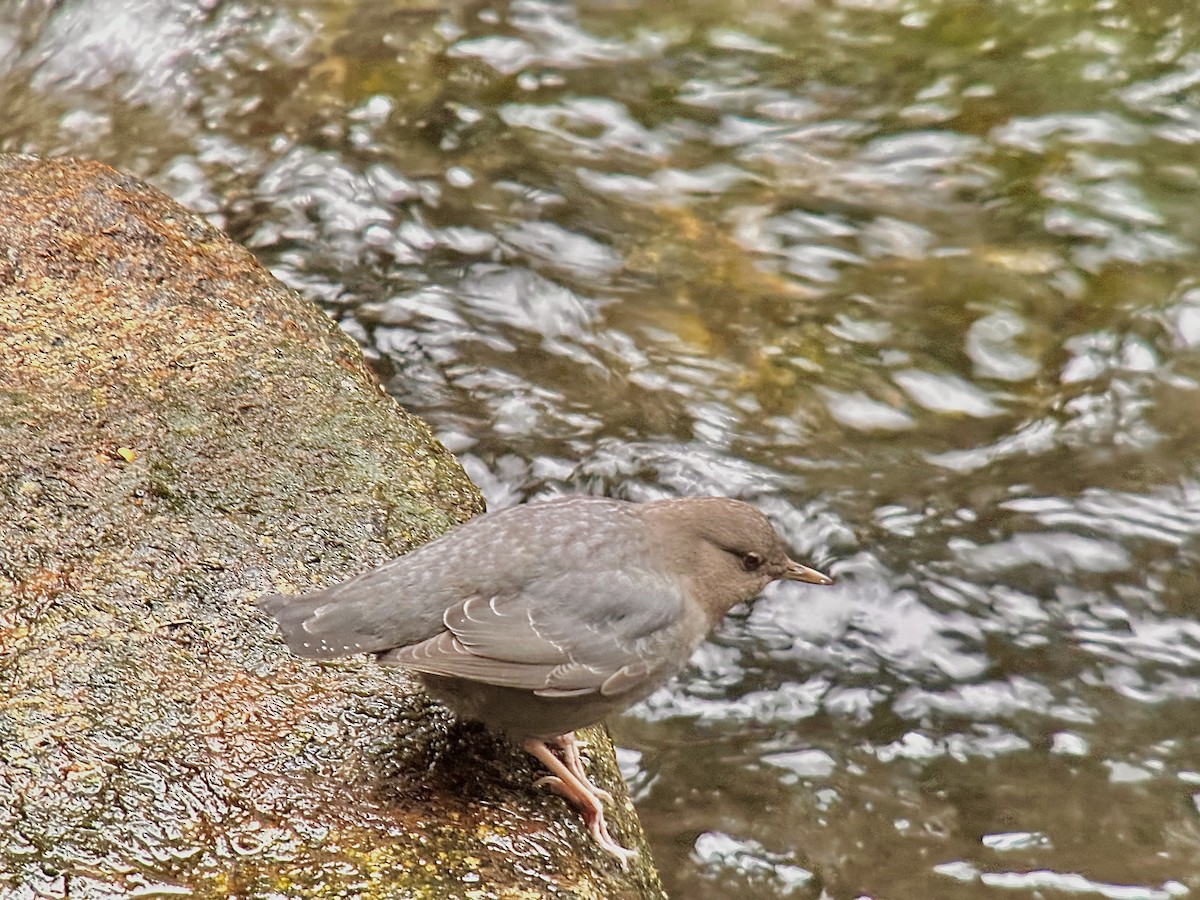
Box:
left=384, top=575, right=686, bottom=697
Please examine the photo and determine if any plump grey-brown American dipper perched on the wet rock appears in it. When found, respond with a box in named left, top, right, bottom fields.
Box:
left=258, top=497, right=833, bottom=860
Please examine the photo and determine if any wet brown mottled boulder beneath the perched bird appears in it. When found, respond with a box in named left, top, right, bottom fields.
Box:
left=0, top=156, right=661, bottom=899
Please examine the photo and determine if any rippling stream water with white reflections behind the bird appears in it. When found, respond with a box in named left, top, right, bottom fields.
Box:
left=0, top=0, right=1200, bottom=900
